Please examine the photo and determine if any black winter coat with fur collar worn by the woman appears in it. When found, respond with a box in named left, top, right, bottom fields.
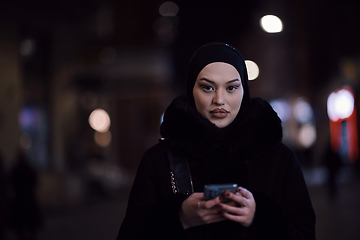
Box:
left=117, top=98, right=315, bottom=240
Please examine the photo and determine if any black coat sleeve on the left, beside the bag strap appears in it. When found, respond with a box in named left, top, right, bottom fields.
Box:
left=117, top=145, right=186, bottom=240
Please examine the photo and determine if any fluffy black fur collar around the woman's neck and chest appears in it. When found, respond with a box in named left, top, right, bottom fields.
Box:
left=160, top=96, right=282, bottom=186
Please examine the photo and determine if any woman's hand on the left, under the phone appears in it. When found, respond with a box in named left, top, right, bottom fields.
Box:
left=180, top=193, right=226, bottom=229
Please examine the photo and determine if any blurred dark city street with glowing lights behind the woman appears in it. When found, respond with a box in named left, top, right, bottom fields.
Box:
left=0, top=0, right=360, bottom=240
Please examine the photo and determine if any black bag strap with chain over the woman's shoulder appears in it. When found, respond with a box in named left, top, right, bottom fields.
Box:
left=159, top=138, right=194, bottom=195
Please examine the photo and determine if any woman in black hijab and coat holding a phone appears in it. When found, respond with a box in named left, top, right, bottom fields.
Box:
left=118, top=43, right=315, bottom=239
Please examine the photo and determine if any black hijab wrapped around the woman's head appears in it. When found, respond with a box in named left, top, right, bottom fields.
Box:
left=186, top=42, right=250, bottom=125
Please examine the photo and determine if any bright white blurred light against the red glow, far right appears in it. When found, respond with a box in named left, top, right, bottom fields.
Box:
left=327, top=89, right=354, bottom=122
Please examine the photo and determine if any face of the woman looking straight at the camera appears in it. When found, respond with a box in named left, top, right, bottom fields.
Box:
left=193, top=62, right=244, bottom=128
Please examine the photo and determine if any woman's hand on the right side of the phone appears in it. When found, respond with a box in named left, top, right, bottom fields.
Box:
left=219, top=187, right=256, bottom=227
